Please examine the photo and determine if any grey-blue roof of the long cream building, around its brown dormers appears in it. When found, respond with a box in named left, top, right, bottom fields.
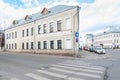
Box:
left=8, top=5, right=77, bottom=29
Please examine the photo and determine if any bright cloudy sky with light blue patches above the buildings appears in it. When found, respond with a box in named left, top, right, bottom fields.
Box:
left=0, top=0, right=120, bottom=33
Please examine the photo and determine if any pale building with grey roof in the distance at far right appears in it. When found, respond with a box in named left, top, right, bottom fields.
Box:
left=89, top=26, right=120, bottom=48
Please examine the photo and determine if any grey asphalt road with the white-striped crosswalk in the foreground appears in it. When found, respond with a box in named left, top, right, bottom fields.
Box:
left=0, top=49, right=120, bottom=80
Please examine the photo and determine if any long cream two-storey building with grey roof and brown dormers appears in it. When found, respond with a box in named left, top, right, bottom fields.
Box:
left=5, top=5, right=79, bottom=53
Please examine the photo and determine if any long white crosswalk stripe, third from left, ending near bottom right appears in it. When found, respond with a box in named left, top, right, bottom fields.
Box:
left=50, top=68, right=101, bottom=78
